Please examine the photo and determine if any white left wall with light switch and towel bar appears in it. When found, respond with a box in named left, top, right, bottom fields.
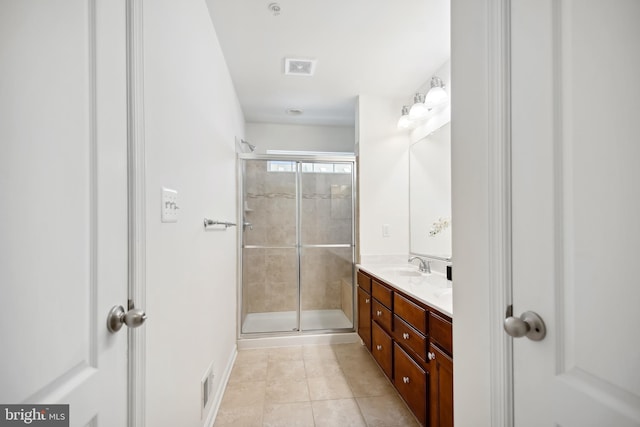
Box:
left=144, top=0, right=244, bottom=427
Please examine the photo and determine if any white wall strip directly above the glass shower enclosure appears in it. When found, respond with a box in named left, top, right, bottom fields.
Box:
left=245, top=123, right=355, bottom=153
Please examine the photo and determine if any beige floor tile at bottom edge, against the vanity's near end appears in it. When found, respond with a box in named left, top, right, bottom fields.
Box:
left=356, top=394, right=419, bottom=427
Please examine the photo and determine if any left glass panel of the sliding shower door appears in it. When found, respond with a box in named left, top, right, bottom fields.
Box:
left=241, top=160, right=299, bottom=334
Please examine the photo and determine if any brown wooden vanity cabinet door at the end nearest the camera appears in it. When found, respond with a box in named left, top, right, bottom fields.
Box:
left=429, top=344, right=453, bottom=427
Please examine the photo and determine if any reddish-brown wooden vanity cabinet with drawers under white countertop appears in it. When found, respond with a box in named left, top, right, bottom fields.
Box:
left=358, top=271, right=453, bottom=427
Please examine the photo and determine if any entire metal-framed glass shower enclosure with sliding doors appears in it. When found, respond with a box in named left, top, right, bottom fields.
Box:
left=238, top=154, right=355, bottom=335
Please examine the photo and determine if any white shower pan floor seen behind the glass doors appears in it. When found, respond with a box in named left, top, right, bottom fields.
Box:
left=242, top=309, right=353, bottom=334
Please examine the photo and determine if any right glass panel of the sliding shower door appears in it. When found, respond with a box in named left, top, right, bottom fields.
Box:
left=299, top=162, right=354, bottom=331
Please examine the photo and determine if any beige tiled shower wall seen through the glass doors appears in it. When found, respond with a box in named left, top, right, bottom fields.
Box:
left=242, top=160, right=353, bottom=319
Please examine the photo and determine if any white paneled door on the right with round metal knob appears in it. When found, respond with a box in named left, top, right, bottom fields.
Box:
left=511, top=0, right=640, bottom=427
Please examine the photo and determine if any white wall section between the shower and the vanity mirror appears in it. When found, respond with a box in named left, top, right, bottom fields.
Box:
left=357, top=95, right=409, bottom=256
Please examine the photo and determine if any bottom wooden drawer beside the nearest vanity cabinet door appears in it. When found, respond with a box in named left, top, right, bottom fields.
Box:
left=393, top=344, right=427, bottom=425
